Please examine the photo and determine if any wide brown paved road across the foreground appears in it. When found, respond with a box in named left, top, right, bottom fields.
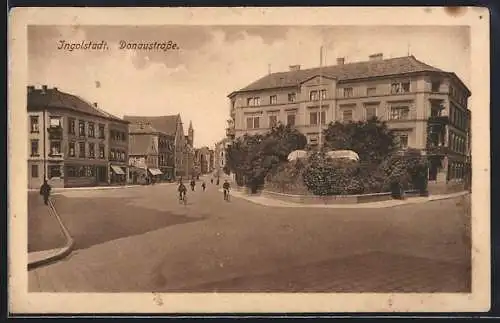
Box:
left=29, top=184, right=470, bottom=292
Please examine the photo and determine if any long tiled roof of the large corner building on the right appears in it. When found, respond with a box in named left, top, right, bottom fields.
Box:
left=229, top=56, right=468, bottom=97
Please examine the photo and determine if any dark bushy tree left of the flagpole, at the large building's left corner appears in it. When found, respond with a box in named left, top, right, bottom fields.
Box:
left=227, top=124, right=307, bottom=192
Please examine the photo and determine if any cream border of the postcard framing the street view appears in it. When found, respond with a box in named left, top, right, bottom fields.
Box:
left=8, top=7, right=491, bottom=313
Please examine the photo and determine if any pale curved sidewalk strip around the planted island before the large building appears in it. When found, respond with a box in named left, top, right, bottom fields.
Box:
left=223, top=189, right=470, bottom=209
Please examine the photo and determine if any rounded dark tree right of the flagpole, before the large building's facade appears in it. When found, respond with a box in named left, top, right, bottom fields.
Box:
left=324, top=118, right=396, bottom=164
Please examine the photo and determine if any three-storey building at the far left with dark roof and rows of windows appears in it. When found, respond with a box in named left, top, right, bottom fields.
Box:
left=27, top=85, right=128, bottom=188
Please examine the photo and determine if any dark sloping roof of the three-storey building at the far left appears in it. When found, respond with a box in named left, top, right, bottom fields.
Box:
left=28, top=88, right=127, bottom=123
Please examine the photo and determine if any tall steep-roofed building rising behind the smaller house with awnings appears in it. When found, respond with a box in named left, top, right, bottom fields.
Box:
left=123, top=114, right=194, bottom=179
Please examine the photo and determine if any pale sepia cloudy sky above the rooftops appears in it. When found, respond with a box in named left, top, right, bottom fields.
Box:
left=28, top=26, right=471, bottom=147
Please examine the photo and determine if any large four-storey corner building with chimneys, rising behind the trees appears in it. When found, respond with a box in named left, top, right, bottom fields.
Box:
left=227, top=54, right=471, bottom=181
